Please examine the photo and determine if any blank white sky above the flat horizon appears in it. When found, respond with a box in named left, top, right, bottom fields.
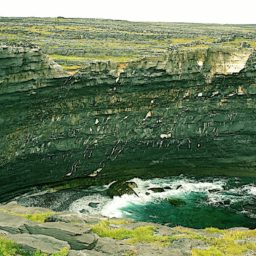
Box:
left=0, top=0, right=256, bottom=24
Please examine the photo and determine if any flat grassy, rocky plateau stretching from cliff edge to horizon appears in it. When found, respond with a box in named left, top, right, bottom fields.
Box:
left=0, top=17, right=256, bottom=74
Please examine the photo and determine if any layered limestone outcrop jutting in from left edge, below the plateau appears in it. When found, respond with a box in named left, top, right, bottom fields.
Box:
left=0, top=45, right=65, bottom=94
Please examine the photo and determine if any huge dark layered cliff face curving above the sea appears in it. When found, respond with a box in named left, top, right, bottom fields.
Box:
left=0, top=48, right=256, bottom=200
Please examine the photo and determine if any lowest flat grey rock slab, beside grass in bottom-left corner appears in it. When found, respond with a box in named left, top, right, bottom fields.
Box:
left=7, top=234, right=70, bottom=253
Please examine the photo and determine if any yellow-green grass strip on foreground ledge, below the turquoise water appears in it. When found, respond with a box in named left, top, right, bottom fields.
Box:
left=92, top=220, right=256, bottom=256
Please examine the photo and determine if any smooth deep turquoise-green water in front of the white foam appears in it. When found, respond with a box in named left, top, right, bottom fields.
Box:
left=122, top=193, right=256, bottom=228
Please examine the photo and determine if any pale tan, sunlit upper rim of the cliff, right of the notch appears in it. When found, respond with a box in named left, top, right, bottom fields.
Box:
left=78, top=47, right=255, bottom=85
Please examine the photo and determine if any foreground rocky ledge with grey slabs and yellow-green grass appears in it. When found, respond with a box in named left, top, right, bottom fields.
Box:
left=0, top=201, right=256, bottom=256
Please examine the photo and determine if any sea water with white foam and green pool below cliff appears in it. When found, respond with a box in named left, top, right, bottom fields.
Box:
left=19, top=175, right=256, bottom=228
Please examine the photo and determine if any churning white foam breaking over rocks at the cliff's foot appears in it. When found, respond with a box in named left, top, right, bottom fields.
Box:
left=69, top=176, right=256, bottom=218
